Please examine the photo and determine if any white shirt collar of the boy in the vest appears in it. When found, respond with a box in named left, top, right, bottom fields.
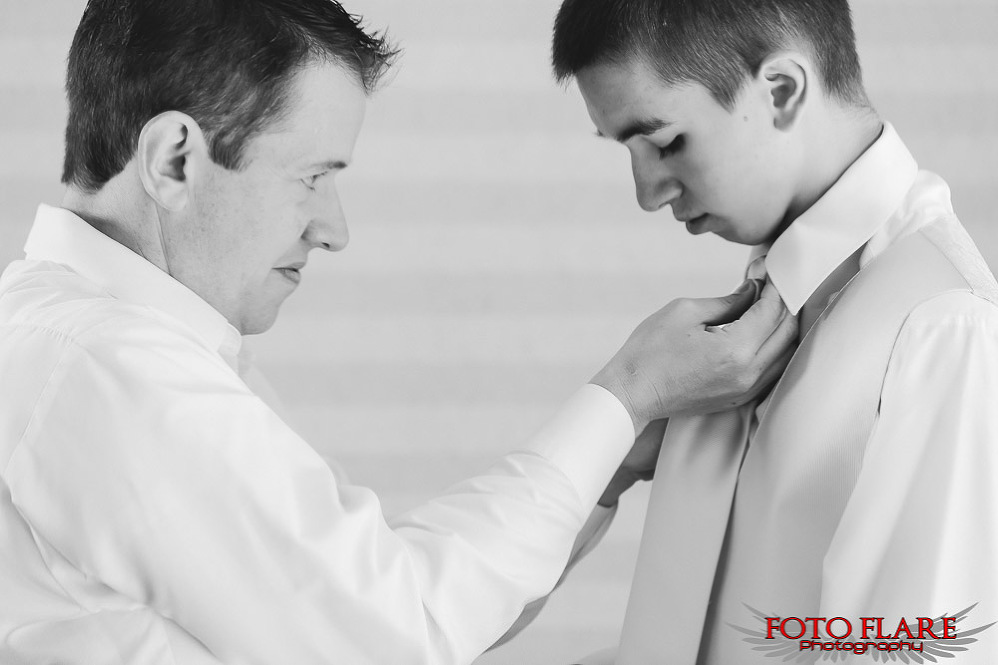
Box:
left=750, top=123, right=918, bottom=314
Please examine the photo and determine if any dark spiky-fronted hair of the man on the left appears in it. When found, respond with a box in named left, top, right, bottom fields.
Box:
left=62, top=0, right=397, bottom=192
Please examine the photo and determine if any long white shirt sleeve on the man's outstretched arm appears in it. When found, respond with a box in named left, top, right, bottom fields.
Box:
left=5, top=323, right=634, bottom=665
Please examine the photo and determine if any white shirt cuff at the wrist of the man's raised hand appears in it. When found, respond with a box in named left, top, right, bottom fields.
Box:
left=526, top=383, right=635, bottom=511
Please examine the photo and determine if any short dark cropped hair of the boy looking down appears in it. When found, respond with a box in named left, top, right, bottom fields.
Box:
left=552, top=0, right=868, bottom=110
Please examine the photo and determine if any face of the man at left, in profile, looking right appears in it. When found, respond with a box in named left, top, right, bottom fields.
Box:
left=180, top=64, right=366, bottom=334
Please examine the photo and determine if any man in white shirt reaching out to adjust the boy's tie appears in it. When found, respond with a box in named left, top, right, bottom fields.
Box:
left=0, top=0, right=795, bottom=665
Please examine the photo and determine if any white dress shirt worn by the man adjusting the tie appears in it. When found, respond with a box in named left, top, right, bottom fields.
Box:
left=0, top=206, right=634, bottom=665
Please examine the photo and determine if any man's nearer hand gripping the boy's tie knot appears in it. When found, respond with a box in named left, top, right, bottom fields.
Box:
left=590, top=281, right=797, bottom=432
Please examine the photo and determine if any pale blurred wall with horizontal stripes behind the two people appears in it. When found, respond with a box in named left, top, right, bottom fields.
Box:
left=0, top=0, right=998, bottom=665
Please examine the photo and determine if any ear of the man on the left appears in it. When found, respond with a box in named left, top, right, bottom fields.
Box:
left=135, top=111, right=209, bottom=211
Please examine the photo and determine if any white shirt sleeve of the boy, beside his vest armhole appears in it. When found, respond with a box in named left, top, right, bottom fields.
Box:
left=821, top=293, right=998, bottom=665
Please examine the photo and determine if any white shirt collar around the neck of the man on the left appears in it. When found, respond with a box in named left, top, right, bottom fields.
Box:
left=24, top=204, right=242, bottom=362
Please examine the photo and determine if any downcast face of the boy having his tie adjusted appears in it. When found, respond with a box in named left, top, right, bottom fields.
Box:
left=577, top=61, right=797, bottom=245
